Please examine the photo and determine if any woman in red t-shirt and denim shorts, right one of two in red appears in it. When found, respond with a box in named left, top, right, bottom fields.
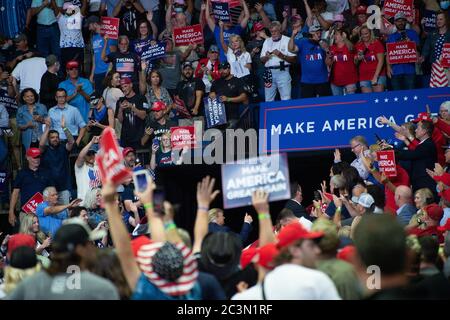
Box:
left=355, top=26, right=386, bottom=93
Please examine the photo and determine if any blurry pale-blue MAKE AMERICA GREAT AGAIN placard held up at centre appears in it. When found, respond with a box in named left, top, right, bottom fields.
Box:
left=222, top=153, right=291, bottom=209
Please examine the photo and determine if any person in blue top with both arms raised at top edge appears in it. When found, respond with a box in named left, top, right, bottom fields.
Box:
left=205, top=0, right=250, bottom=62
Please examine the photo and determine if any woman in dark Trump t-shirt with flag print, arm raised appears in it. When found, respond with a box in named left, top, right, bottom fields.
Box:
left=102, top=36, right=140, bottom=90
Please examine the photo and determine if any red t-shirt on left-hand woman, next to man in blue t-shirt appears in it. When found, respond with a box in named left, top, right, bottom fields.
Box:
left=330, top=45, right=358, bottom=86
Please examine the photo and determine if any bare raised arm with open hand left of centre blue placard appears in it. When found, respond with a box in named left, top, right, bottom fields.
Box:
left=192, top=176, right=219, bottom=253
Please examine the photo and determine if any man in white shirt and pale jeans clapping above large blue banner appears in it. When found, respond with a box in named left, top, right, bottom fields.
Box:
left=260, top=21, right=296, bottom=102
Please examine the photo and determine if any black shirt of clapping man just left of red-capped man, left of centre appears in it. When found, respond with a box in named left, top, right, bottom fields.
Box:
left=115, top=94, right=148, bottom=147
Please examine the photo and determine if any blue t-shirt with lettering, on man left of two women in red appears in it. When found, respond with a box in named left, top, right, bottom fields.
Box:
left=295, top=39, right=328, bottom=84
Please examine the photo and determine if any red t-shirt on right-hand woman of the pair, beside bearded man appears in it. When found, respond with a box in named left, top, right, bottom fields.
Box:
left=355, top=40, right=386, bottom=81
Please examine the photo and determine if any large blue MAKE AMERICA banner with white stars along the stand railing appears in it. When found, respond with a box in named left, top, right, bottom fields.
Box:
left=260, top=88, right=450, bottom=153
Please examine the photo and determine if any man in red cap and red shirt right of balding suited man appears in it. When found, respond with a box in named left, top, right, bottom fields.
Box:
left=408, top=203, right=444, bottom=243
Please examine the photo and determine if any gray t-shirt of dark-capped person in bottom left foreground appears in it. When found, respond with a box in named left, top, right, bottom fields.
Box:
left=6, top=271, right=119, bottom=300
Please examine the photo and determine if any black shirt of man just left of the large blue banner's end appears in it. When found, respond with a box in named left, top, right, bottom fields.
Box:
left=211, top=77, right=245, bottom=121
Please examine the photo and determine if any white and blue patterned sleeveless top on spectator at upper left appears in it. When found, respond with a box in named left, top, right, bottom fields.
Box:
left=56, top=11, right=84, bottom=48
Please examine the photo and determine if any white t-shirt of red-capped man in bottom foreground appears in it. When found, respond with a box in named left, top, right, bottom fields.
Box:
left=231, top=264, right=341, bottom=300
